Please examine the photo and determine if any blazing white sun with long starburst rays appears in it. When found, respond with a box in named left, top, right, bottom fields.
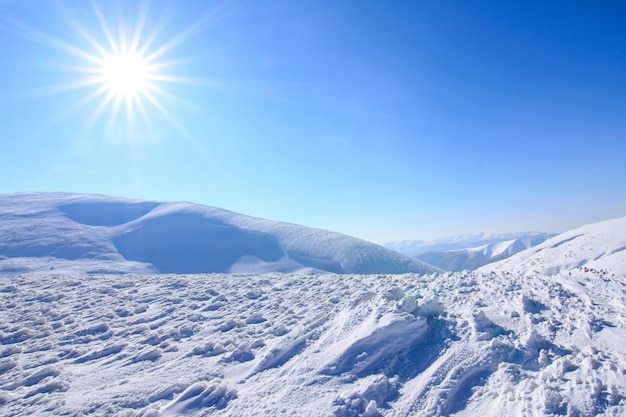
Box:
left=0, top=0, right=238, bottom=136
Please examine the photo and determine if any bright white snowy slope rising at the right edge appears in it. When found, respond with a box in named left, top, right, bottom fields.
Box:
left=481, top=217, right=626, bottom=276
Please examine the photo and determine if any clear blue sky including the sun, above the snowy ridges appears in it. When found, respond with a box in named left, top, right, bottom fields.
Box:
left=0, top=0, right=626, bottom=243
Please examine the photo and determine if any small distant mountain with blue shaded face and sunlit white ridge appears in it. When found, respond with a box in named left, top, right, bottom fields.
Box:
left=415, top=233, right=547, bottom=272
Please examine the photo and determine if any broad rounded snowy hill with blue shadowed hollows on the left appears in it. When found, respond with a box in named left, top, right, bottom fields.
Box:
left=0, top=193, right=436, bottom=274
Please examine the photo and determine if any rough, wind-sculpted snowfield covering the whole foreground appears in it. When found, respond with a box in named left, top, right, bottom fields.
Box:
left=0, top=268, right=626, bottom=417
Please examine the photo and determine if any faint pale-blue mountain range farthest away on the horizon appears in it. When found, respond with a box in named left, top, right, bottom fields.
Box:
left=383, top=232, right=555, bottom=256
